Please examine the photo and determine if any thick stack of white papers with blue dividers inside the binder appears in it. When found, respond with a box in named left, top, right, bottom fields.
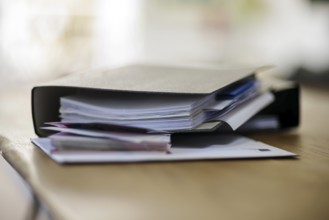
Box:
left=60, top=79, right=273, bottom=132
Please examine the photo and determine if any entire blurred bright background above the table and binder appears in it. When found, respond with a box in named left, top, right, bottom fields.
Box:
left=0, top=0, right=329, bottom=87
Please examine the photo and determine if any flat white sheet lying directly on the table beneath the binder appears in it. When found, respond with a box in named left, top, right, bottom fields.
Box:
left=32, top=134, right=296, bottom=163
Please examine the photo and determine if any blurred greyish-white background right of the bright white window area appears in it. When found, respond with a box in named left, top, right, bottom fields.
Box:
left=143, top=0, right=329, bottom=75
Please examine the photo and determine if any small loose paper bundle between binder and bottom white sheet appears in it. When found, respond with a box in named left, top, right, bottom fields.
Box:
left=50, top=128, right=171, bottom=153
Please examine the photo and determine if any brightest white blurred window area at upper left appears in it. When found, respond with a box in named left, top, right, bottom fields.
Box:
left=0, top=0, right=140, bottom=87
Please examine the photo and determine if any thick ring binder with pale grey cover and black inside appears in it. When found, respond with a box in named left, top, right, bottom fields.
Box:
left=32, top=65, right=299, bottom=137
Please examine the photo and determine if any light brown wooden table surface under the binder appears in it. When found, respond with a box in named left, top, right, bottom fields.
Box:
left=0, top=83, right=329, bottom=220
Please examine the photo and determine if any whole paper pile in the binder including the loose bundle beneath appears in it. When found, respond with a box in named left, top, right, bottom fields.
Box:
left=44, top=78, right=274, bottom=155
